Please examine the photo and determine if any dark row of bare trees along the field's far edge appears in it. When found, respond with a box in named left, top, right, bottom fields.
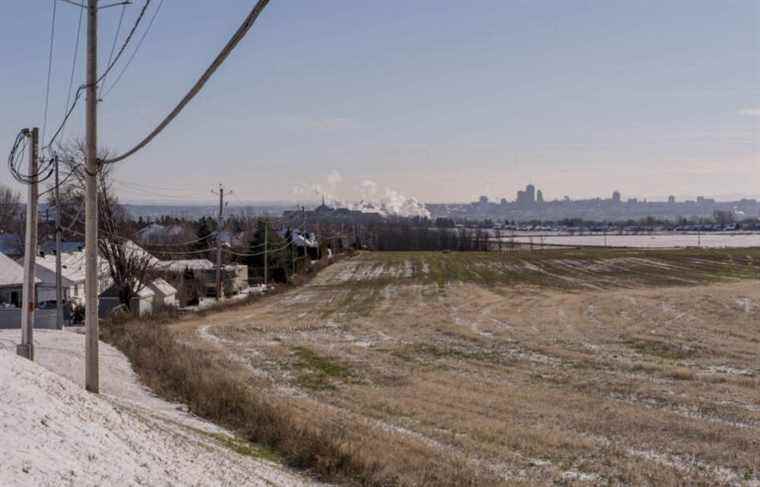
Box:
left=369, top=223, right=493, bottom=252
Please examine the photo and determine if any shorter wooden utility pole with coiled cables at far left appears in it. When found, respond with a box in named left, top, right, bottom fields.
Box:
left=16, top=127, right=40, bottom=360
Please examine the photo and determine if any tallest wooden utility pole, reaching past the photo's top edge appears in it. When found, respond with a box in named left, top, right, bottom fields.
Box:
left=84, top=0, right=100, bottom=393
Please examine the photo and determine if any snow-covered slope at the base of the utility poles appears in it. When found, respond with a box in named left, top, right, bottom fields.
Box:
left=0, top=330, right=314, bottom=487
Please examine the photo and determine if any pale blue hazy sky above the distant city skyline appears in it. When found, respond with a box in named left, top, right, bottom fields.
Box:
left=0, top=0, right=760, bottom=202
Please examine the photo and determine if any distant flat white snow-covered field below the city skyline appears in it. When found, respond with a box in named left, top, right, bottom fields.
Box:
left=504, top=233, right=760, bottom=249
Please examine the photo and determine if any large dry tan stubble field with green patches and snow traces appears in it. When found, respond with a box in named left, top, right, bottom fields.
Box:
left=166, top=250, right=760, bottom=485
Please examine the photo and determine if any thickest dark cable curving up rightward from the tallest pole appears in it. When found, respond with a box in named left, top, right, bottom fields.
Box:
left=103, top=0, right=269, bottom=164
